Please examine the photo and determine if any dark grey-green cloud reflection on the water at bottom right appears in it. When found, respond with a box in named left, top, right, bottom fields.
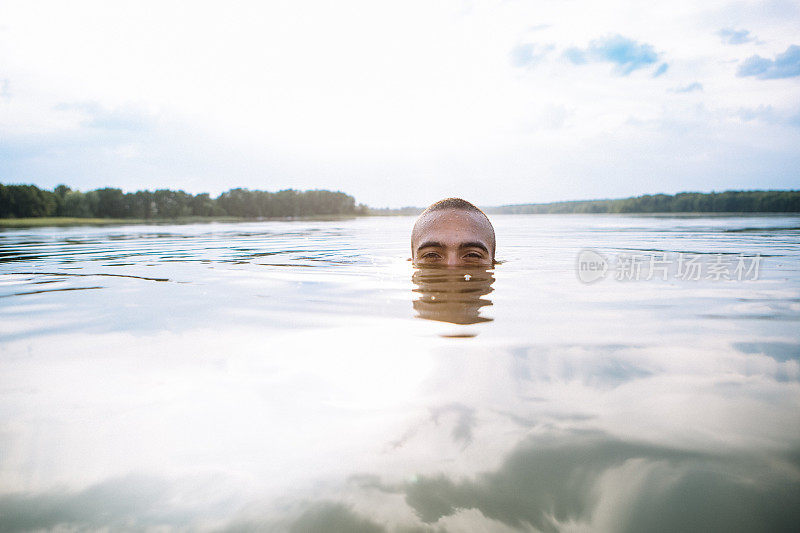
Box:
left=403, top=434, right=800, bottom=531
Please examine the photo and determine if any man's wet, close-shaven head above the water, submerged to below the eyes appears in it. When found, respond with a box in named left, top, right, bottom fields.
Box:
left=411, top=198, right=495, bottom=267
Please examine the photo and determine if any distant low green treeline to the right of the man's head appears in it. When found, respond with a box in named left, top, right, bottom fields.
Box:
left=485, top=191, right=800, bottom=214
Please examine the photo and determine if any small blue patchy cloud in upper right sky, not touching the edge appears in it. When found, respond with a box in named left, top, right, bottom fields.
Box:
left=564, top=34, right=667, bottom=76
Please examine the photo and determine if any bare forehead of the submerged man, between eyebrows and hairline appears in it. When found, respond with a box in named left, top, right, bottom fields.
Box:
left=412, top=209, right=492, bottom=248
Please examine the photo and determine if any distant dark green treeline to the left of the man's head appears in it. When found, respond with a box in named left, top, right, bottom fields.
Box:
left=0, top=184, right=367, bottom=219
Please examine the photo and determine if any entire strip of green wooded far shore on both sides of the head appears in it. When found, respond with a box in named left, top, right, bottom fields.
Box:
left=0, top=184, right=800, bottom=227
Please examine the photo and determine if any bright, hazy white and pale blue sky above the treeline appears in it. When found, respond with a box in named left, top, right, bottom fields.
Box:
left=0, top=0, right=800, bottom=207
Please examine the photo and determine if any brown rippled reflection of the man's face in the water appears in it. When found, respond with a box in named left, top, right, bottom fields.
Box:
left=411, top=267, right=494, bottom=325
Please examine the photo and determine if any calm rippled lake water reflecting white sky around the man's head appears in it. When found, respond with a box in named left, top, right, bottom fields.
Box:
left=0, top=215, right=800, bottom=532
